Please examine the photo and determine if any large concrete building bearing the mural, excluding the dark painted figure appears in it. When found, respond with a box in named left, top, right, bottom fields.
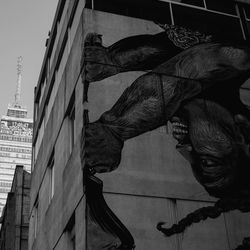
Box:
left=29, top=0, right=250, bottom=250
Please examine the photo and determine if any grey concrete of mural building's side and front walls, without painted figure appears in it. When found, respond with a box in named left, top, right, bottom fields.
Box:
left=29, top=0, right=249, bottom=250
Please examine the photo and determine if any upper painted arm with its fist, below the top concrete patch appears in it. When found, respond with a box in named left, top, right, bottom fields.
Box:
left=81, top=32, right=182, bottom=82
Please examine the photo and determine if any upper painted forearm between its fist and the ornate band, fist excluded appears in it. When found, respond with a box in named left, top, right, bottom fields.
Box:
left=107, top=32, right=182, bottom=72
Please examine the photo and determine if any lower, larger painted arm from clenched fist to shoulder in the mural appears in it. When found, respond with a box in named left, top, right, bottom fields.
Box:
left=83, top=43, right=250, bottom=172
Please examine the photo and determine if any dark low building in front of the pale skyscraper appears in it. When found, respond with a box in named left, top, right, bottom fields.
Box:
left=0, top=165, right=31, bottom=250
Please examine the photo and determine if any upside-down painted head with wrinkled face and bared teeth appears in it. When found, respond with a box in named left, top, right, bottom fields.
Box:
left=175, top=101, right=250, bottom=197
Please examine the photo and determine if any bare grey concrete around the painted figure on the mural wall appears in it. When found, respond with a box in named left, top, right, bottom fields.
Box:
left=83, top=10, right=250, bottom=250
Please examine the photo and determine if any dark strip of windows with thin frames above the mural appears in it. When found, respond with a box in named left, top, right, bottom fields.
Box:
left=85, top=0, right=247, bottom=39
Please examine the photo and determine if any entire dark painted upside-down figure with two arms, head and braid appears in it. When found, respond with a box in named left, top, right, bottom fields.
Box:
left=82, top=25, right=250, bottom=249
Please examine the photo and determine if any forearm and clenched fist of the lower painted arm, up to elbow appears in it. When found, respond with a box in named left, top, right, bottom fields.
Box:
left=85, top=73, right=201, bottom=172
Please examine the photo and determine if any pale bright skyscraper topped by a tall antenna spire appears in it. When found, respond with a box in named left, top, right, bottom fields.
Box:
left=0, top=58, right=33, bottom=213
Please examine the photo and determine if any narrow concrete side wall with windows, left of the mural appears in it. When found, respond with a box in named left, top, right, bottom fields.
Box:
left=29, top=1, right=85, bottom=249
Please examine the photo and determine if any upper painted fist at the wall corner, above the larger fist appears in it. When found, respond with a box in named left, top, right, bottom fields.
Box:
left=81, top=33, right=119, bottom=82
